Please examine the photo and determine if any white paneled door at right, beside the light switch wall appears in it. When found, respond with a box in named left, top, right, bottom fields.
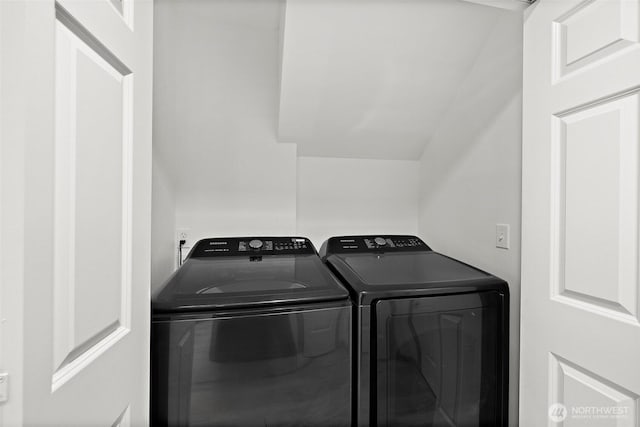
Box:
left=520, top=0, right=640, bottom=427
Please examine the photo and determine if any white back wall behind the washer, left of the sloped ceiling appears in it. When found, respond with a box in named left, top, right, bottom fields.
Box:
left=154, top=0, right=296, bottom=251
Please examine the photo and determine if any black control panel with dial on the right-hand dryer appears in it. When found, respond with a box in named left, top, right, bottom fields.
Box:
left=323, top=235, right=431, bottom=255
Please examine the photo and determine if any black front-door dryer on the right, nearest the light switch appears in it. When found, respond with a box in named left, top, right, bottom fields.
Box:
left=320, top=235, right=509, bottom=427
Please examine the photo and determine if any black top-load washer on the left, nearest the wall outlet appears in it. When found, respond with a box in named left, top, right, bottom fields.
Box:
left=151, top=237, right=352, bottom=427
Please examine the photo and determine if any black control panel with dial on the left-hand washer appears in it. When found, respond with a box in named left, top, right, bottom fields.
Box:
left=189, top=237, right=316, bottom=258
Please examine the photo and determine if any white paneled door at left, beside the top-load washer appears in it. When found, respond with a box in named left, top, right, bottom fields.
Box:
left=0, top=0, right=153, bottom=426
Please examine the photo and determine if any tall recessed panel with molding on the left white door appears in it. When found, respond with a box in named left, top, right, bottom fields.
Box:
left=51, top=7, right=133, bottom=391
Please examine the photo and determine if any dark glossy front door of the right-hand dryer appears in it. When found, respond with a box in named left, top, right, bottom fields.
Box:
left=371, top=292, right=507, bottom=427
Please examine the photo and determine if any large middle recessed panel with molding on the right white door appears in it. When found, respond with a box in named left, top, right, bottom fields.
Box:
left=550, top=89, right=640, bottom=323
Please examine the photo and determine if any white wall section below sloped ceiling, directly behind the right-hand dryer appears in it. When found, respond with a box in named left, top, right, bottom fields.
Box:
left=297, top=157, right=420, bottom=249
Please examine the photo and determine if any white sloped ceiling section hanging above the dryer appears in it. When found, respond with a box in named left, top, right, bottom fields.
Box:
left=278, top=0, right=512, bottom=160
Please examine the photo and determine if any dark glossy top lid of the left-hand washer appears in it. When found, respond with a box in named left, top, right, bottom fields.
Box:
left=152, top=238, right=348, bottom=313
